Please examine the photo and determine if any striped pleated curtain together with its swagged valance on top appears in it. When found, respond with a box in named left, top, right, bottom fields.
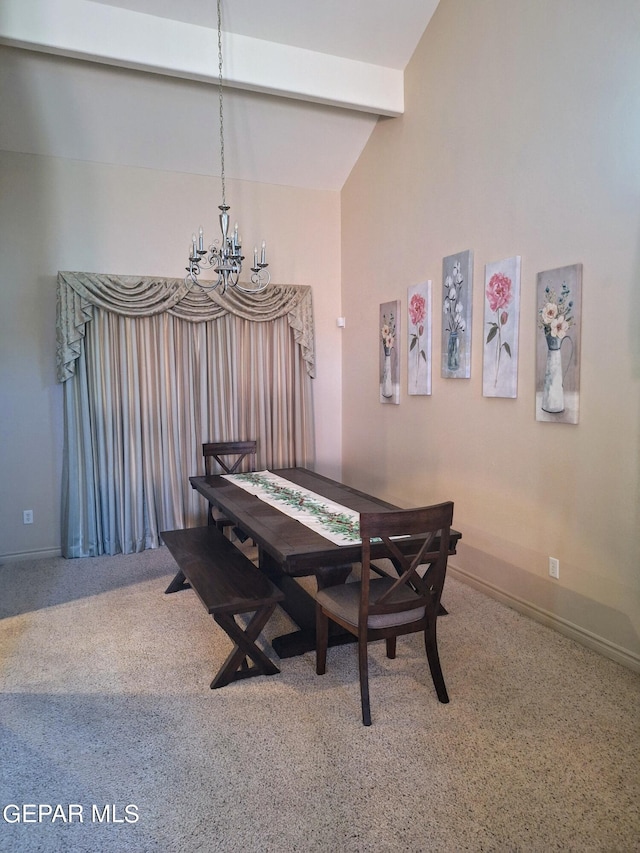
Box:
left=57, top=272, right=315, bottom=557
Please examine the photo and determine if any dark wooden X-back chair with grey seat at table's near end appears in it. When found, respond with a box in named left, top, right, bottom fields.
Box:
left=316, top=502, right=453, bottom=726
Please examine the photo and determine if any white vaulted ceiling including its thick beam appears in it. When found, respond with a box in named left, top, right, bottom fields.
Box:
left=0, top=0, right=438, bottom=190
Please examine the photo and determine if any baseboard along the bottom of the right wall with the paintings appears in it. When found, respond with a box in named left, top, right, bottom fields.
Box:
left=449, top=564, right=640, bottom=672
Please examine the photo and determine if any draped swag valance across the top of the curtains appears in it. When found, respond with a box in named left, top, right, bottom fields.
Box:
left=56, top=272, right=315, bottom=382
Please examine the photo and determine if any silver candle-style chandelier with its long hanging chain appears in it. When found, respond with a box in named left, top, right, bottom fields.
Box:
left=184, top=0, right=271, bottom=293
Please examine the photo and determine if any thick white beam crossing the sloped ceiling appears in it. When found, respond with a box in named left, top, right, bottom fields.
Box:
left=0, top=0, right=404, bottom=116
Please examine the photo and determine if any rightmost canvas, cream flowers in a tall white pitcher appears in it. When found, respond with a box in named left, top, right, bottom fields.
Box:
left=536, top=264, right=582, bottom=424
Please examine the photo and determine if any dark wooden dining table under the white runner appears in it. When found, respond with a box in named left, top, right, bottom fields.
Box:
left=189, top=468, right=462, bottom=658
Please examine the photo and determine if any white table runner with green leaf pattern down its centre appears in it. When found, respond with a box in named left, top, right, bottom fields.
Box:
left=222, top=471, right=361, bottom=545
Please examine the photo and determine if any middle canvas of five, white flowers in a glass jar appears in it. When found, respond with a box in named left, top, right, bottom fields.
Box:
left=441, top=249, right=473, bottom=379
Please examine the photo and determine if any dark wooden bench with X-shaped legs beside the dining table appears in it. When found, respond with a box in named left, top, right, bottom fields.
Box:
left=160, top=526, right=284, bottom=688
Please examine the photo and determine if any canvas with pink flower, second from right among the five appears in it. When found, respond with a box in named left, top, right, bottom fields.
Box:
left=482, top=255, right=520, bottom=398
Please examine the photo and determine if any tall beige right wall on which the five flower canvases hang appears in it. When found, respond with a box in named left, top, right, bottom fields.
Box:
left=342, top=0, right=640, bottom=666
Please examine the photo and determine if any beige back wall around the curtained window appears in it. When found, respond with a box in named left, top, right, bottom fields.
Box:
left=0, top=151, right=342, bottom=557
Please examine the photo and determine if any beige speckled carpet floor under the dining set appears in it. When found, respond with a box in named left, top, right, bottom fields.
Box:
left=0, top=548, right=640, bottom=853
